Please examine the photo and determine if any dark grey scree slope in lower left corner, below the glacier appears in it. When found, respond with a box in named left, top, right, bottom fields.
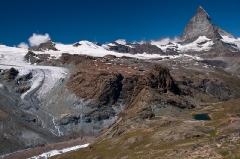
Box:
left=0, top=92, right=57, bottom=155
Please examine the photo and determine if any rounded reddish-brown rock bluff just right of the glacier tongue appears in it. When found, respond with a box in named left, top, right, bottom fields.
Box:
left=67, top=70, right=123, bottom=105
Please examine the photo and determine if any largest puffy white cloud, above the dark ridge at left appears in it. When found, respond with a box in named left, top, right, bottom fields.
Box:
left=28, top=33, right=51, bottom=46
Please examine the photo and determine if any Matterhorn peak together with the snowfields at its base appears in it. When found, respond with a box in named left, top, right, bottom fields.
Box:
left=151, top=6, right=240, bottom=54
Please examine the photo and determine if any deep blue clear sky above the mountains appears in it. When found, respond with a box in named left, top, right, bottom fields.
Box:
left=0, top=0, right=240, bottom=46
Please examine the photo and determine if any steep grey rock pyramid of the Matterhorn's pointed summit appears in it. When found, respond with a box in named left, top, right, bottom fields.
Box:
left=182, top=6, right=212, bottom=42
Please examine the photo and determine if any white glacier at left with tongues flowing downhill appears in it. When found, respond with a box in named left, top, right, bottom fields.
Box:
left=0, top=45, right=68, bottom=99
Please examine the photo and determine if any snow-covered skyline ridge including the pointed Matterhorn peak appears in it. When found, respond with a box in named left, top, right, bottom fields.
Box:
left=14, top=7, right=240, bottom=58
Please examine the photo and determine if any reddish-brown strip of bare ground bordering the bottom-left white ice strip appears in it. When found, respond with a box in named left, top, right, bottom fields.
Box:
left=3, top=137, right=96, bottom=159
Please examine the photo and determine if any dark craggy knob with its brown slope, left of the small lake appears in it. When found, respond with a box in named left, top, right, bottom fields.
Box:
left=100, top=65, right=195, bottom=137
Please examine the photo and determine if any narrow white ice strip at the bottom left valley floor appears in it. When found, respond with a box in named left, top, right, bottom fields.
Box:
left=29, top=144, right=89, bottom=159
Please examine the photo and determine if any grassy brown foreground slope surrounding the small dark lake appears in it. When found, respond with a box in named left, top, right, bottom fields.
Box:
left=54, top=99, right=240, bottom=159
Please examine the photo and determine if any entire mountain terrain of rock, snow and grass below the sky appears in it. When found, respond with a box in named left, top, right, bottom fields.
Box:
left=0, top=7, right=240, bottom=159
